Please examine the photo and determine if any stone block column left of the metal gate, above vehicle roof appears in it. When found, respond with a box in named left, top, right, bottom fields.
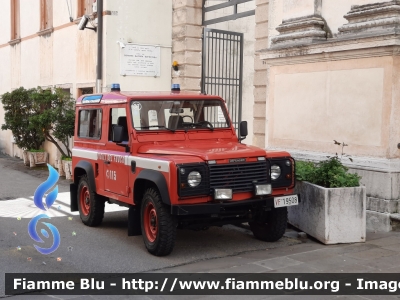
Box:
left=171, top=0, right=202, bottom=91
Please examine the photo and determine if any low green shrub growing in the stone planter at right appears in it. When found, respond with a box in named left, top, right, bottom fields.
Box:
left=296, top=156, right=361, bottom=188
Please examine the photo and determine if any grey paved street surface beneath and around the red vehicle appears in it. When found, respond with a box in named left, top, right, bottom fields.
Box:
left=0, top=154, right=400, bottom=300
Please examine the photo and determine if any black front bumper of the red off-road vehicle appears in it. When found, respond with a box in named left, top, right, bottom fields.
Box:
left=171, top=195, right=300, bottom=216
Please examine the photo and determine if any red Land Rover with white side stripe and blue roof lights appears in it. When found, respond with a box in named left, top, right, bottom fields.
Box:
left=71, top=85, right=299, bottom=256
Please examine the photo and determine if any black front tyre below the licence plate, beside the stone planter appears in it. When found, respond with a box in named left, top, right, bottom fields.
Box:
left=249, top=207, right=287, bottom=242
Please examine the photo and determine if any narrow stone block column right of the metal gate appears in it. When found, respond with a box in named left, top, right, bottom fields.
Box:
left=253, top=0, right=269, bottom=148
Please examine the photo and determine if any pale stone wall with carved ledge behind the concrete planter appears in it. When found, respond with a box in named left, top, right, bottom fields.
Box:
left=261, top=0, right=400, bottom=231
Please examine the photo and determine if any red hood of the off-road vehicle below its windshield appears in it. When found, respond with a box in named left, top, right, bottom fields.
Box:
left=138, top=141, right=266, bottom=160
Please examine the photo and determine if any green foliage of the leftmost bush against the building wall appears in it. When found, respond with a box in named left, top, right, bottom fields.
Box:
left=1, top=87, right=45, bottom=150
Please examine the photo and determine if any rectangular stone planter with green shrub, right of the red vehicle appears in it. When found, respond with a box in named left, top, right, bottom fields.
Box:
left=288, top=141, right=366, bottom=244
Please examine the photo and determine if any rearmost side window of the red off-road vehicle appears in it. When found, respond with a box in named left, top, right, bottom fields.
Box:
left=78, top=109, right=102, bottom=140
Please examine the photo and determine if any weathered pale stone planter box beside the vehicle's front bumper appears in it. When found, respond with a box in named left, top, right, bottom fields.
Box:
left=288, top=181, right=366, bottom=244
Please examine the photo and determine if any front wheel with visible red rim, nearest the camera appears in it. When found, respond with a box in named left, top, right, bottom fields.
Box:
left=140, top=188, right=177, bottom=256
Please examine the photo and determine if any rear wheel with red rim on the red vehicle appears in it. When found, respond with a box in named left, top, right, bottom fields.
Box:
left=78, top=175, right=105, bottom=227
